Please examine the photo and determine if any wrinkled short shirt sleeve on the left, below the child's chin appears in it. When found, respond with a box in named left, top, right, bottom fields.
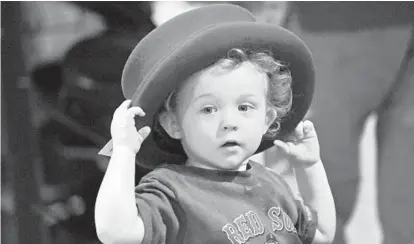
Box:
left=135, top=177, right=179, bottom=244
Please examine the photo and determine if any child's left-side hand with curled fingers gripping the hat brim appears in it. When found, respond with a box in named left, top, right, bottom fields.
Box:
left=111, top=100, right=151, bottom=154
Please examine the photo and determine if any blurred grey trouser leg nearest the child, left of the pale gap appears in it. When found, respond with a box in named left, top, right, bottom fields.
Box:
left=288, top=16, right=408, bottom=243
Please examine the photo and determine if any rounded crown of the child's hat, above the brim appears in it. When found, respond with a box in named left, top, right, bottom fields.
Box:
left=122, top=4, right=256, bottom=99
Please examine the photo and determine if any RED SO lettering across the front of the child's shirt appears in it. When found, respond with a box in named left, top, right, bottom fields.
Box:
left=222, top=207, right=297, bottom=244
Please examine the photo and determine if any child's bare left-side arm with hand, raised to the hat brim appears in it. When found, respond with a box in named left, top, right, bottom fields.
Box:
left=95, top=100, right=150, bottom=244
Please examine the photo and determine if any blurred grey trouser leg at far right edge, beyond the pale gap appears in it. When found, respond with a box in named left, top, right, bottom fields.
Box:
left=377, top=24, right=414, bottom=244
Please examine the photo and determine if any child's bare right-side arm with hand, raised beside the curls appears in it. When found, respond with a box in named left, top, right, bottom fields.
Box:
left=275, top=121, right=336, bottom=244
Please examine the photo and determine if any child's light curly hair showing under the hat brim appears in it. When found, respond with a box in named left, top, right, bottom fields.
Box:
left=160, top=48, right=292, bottom=139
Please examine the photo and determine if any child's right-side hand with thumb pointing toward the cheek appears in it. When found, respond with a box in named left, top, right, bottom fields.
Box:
left=274, top=120, right=321, bottom=167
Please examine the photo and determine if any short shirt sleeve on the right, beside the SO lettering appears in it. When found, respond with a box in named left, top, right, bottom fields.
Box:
left=295, top=200, right=318, bottom=244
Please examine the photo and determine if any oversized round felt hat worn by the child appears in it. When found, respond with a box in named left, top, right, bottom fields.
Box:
left=99, top=4, right=314, bottom=169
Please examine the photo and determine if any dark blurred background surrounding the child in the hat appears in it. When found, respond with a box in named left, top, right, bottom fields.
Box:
left=1, top=1, right=414, bottom=244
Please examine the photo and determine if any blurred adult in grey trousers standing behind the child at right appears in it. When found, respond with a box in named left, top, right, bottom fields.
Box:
left=287, top=2, right=414, bottom=244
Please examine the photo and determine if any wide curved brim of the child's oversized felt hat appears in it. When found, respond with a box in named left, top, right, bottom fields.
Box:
left=118, top=22, right=314, bottom=169
